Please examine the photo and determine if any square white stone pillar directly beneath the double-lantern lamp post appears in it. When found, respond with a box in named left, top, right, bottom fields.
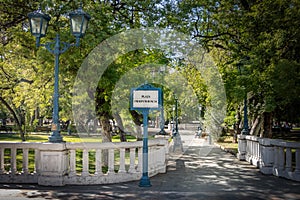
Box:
left=38, top=143, right=69, bottom=186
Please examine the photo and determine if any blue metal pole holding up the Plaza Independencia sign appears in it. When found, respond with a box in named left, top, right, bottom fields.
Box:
left=139, top=109, right=151, bottom=187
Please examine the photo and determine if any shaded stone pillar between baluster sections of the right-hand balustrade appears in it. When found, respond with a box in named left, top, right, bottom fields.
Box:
left=259, top=138, right=274, bottom=174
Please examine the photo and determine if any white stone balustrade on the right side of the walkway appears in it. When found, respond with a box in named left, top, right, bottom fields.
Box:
left=238, top=135, right=300, bottom=181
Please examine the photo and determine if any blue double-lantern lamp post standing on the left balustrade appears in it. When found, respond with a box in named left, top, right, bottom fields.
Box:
left=28, top=6, right=91, bottom=143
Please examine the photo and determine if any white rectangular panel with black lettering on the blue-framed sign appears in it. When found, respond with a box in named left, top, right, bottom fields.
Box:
left=132, top=90, right=159, bottom=108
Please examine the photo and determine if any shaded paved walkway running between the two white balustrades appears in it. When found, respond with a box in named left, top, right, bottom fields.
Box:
left=0, top=131, right=300, bottom=200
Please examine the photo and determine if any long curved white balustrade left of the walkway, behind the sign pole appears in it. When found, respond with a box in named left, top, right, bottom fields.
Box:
left=0, top=139, right=168, bottom=186
